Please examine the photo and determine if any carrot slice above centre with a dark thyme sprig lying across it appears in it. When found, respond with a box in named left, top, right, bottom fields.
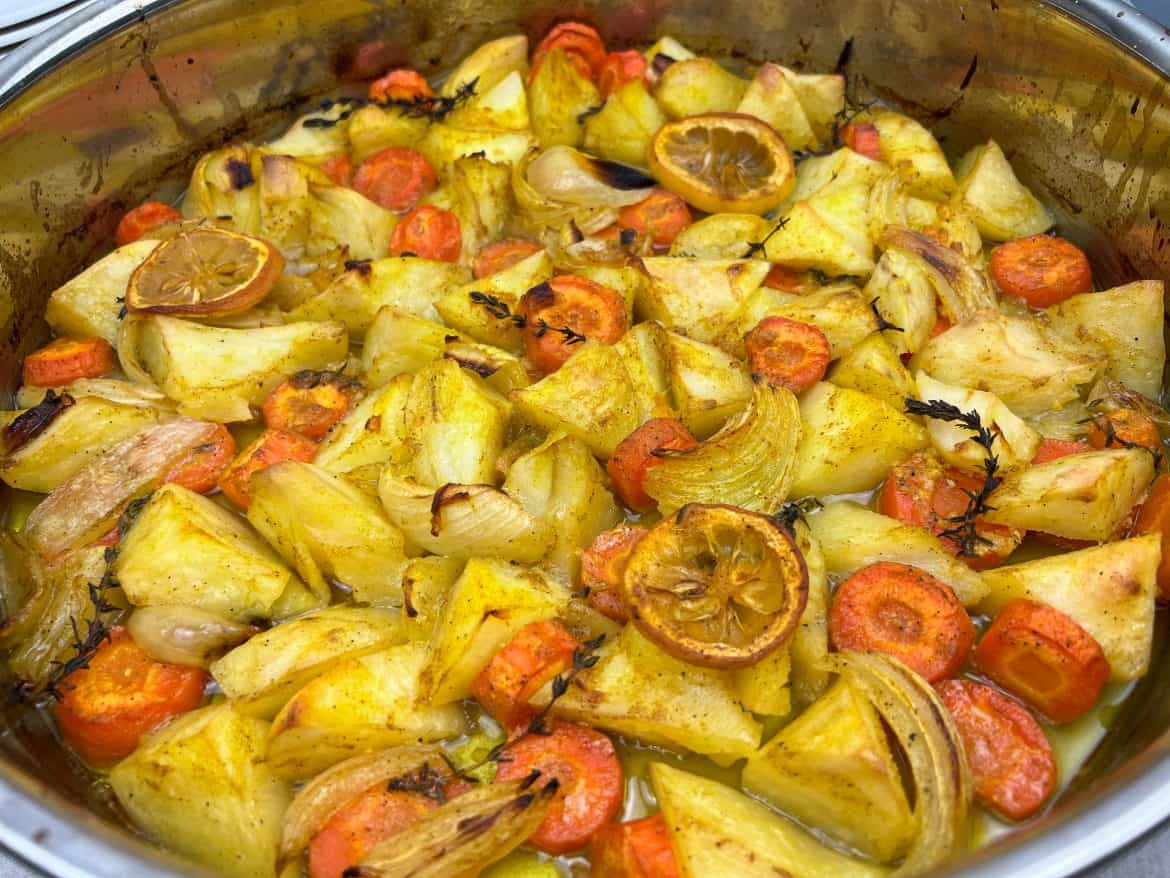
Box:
left=516, top=274, right=627, bottom=372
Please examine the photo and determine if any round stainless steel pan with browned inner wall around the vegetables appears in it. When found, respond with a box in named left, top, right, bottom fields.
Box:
left=0, top=0, right=1170, bottom=878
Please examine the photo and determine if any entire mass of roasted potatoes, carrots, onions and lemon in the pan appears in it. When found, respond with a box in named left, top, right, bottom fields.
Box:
left=0, top=22, right=1170, bottom=878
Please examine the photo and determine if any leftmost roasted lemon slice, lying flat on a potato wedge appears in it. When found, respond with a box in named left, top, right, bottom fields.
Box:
left=126, top=226, right=284, bottom=316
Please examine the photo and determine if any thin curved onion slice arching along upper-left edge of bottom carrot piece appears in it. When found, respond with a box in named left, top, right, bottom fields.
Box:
left=280, top=745, right=450, bottom=862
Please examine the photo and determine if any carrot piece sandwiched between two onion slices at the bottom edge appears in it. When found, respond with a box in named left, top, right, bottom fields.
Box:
left=309, top=783, right=439, bottom=878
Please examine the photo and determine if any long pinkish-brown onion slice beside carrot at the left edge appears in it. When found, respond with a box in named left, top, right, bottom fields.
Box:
left=25, top=418, right=216, bottom=558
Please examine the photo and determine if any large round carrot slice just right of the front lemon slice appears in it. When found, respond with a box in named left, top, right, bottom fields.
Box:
left=828, top=561, right=975, bottom=682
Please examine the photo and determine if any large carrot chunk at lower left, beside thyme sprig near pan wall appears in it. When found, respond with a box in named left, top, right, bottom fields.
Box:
left=57, top=627, right=207, bottom=764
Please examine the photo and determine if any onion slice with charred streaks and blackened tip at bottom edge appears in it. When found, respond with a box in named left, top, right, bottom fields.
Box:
left=346, top=777, right=557, bottom=878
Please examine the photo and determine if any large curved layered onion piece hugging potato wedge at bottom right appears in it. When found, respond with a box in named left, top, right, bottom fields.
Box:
left=831, top=651, right=972, bottom=876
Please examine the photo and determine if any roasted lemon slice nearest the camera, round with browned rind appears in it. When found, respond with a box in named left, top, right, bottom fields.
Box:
left=622, top=503, right=808, bottom=667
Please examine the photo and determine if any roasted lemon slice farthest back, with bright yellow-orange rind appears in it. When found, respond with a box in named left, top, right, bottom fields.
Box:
left=649, top=112, right=796, bottom=213
